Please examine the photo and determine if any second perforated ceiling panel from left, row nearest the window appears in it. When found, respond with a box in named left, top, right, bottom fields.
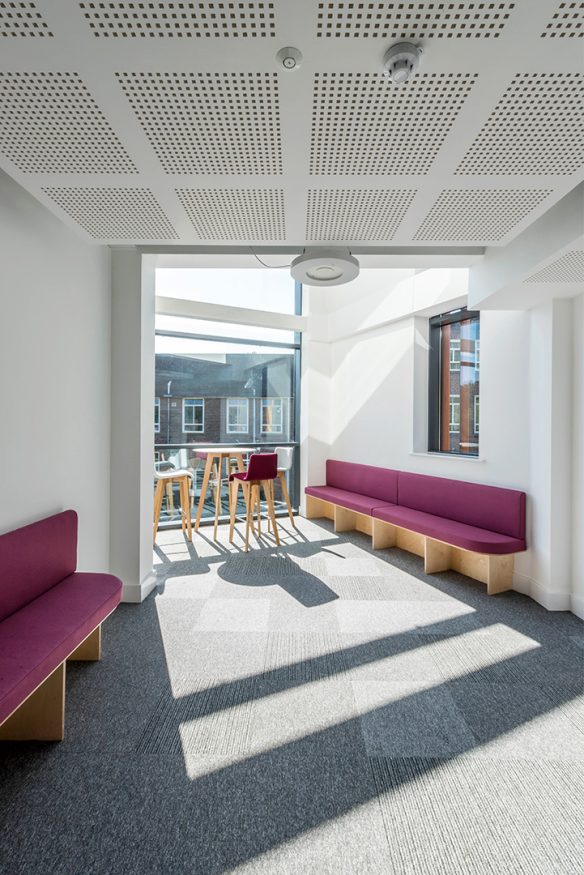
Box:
left=176, top=188, right=286, bottom=241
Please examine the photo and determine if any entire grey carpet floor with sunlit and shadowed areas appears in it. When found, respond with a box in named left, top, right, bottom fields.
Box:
left=0, top=521, right=584, bottom=875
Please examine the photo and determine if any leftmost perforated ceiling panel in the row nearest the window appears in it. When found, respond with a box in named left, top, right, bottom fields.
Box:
left=43, top=187, right=178, bottom=240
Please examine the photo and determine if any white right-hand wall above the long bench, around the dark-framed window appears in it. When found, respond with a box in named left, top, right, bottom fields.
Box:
left=305, top=269, right=584, bottom=610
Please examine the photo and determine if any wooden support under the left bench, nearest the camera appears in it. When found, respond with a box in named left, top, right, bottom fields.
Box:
left=0, top=662, right=65, bottom=741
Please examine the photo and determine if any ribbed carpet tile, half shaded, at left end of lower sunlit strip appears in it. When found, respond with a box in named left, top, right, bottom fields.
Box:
left=136, top=679, right=255, bottom=754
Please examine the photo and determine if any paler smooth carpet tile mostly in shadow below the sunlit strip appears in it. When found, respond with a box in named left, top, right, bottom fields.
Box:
left=352, top=681, right=475, bottom=757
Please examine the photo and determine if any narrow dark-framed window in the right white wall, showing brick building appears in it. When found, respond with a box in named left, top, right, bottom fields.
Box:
left=428, top=308, right=481, bottom=456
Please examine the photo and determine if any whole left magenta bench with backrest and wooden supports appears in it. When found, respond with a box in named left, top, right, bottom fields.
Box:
left=0, top=510, right=122, bottom=740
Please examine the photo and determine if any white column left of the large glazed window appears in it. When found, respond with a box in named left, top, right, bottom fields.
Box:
left=110, top=248, right=156, bottom=602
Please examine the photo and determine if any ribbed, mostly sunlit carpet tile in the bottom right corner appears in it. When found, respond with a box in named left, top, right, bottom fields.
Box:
left=371, top=758, right=584, bottom=875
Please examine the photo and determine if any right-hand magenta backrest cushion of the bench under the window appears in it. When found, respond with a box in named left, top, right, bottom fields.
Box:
left=397, top=471, right=525, bottom=550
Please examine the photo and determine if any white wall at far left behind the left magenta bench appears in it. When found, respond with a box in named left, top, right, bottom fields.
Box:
left=0, top=173, right=110, bottom=570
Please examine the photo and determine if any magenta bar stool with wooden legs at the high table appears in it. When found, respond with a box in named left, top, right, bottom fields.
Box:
left=229, top=453, right=280, bottom=552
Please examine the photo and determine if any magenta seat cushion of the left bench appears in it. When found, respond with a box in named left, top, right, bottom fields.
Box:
left=0, top=572, right=122, bottom=722
